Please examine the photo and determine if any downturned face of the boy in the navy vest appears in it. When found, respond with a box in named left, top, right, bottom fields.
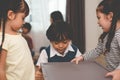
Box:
left=51, top=40, right=70, bottom=54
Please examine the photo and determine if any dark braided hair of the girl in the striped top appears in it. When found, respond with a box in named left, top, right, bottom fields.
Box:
left=96, top=0, right=120, bottom=51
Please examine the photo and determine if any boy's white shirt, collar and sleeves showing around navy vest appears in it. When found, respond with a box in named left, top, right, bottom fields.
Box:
left=36, top=43, right=81, bottom=66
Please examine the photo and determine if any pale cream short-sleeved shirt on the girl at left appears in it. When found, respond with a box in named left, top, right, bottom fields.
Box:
left=0, top=33, right=35, bottom=80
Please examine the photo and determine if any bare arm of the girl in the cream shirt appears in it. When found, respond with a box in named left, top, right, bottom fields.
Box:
left=0, top=50, right=7, bottom=80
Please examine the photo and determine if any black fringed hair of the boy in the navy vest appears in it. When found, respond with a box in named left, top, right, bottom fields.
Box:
left=46, top=22, right=73, bottom=42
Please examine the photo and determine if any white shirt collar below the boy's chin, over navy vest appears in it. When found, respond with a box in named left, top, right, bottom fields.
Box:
left=50, top=42, right=75, bottom=57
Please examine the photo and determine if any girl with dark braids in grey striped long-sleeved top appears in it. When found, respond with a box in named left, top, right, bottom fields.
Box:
left=71, top=0, right=120, bottom=80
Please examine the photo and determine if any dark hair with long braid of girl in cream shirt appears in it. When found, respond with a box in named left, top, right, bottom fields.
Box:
left=0, top=0, right=29, bottom=53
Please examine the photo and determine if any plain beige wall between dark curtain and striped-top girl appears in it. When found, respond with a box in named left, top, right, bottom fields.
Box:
left=85, top=0, right=102, bottom=51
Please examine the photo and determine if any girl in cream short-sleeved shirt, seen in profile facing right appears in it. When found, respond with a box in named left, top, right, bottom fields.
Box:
left=0, top=0, right=35, bottom=80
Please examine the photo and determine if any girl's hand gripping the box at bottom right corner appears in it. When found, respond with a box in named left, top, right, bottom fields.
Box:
left=106, top=69, right=120, bottom=80
